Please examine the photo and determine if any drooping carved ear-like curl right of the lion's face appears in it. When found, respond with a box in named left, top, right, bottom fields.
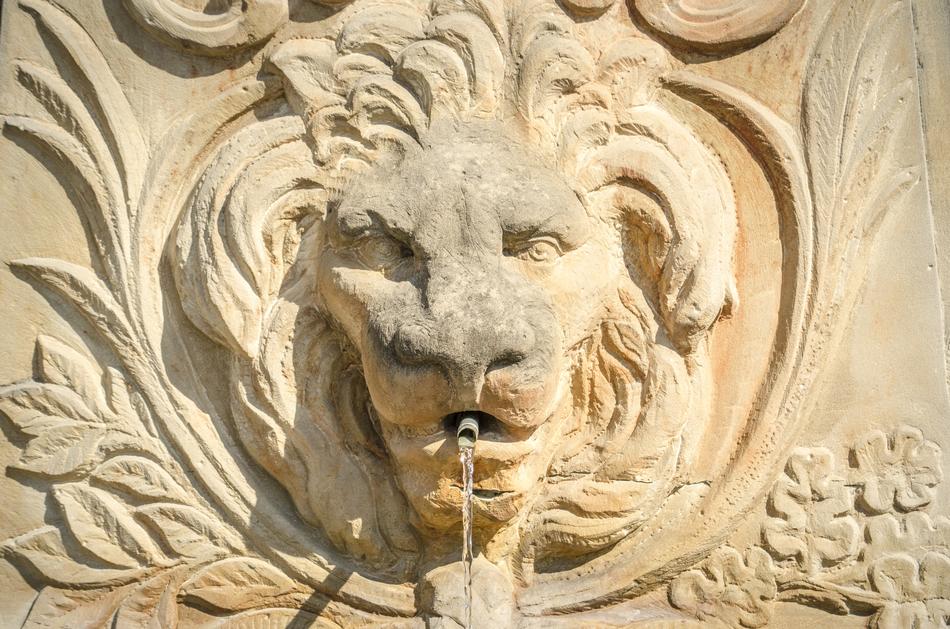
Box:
left=583, top=105, right=737, bottom=354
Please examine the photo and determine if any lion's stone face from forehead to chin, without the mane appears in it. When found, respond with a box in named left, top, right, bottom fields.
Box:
left=317, top=125, right=622, bottom=527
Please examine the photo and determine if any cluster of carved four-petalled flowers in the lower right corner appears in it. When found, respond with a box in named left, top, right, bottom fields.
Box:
left=669, top=426, right=950, bottom=628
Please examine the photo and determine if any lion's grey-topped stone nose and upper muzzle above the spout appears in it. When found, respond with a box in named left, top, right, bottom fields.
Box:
left=360, top=262, right=560, bottom=428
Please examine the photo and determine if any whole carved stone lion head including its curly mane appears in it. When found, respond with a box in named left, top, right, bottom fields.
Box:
left=174, top=0, right=736, bottom=576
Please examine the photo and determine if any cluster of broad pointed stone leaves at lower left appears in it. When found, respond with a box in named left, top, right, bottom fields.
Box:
left=0, top=337, right=258, bottom=602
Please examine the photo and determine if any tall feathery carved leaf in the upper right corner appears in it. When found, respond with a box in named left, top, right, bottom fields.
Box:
left=802, top=0, right=920, bottom=353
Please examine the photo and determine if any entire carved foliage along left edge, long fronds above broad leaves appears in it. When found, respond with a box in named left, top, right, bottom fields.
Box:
left=0, top=0, right=324, bottom=626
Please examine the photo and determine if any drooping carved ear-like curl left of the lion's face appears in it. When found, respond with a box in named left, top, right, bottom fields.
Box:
left=172, top=116, right=326, bottom=356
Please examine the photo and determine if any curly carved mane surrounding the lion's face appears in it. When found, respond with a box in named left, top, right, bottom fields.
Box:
left=173, top=0, right=736, bottom=580
